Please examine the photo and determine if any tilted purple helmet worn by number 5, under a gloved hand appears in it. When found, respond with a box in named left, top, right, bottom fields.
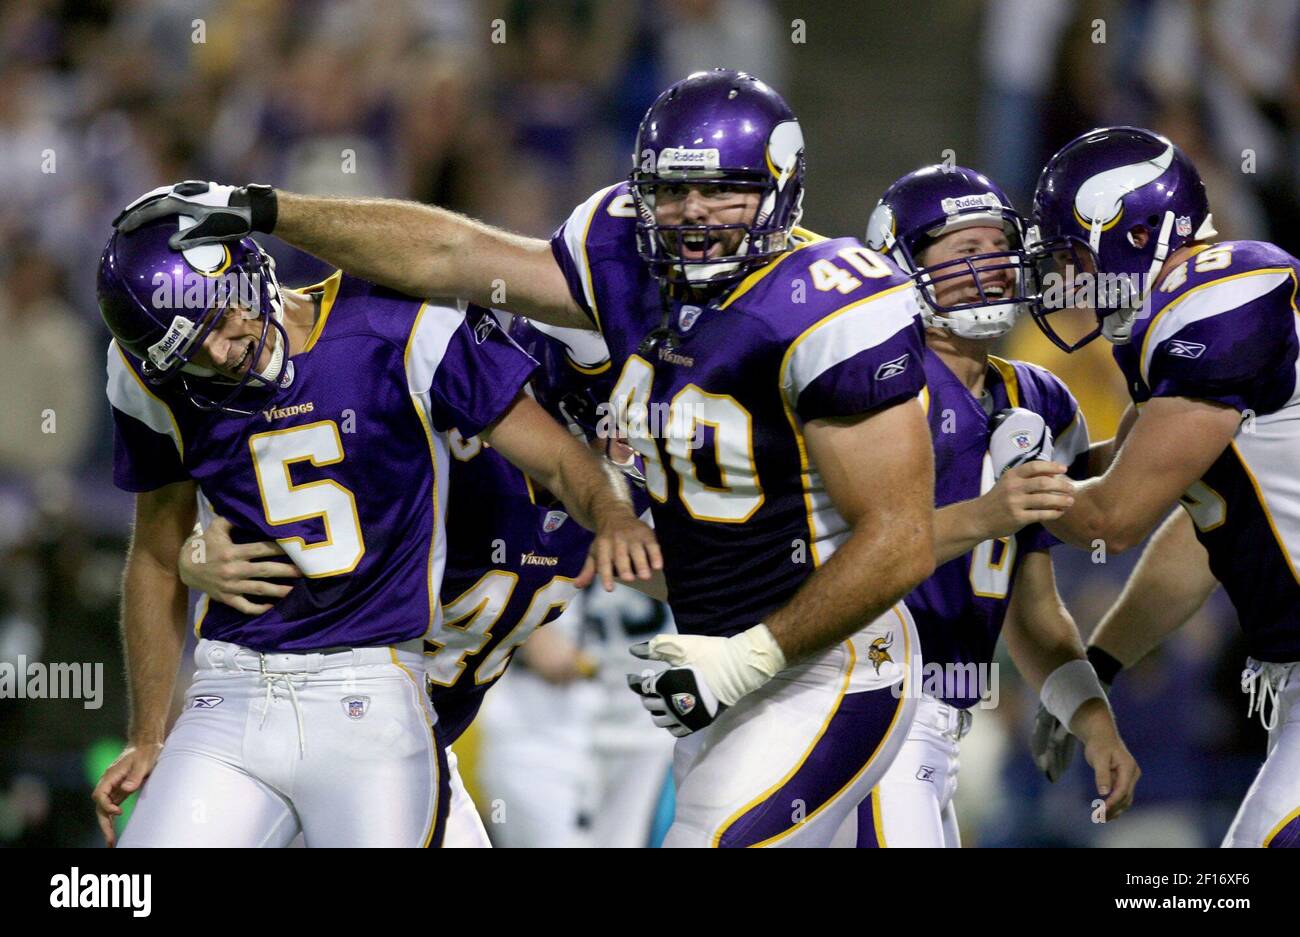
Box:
left=98, top=217, right=293, bottom=415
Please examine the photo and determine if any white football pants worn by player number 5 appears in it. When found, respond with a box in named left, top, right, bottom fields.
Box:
left=120, top=639, right=449, bottom=847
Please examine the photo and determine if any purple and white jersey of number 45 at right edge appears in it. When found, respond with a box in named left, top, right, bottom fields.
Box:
left=1114, top=240, right=1300, bottom=661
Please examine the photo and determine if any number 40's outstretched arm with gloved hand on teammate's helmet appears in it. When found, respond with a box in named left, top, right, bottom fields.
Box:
left=114, top=182, right=592, bottom=329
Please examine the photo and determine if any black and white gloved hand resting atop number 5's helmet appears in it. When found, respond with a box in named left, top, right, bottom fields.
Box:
left=113, top=179, right=276, bottom=251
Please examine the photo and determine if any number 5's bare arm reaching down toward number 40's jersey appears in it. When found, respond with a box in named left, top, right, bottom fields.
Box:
left=480, top=394, right=663, bottom=590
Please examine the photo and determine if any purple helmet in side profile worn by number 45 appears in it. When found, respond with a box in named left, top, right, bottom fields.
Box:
left=1027, top=127, right=1217, bottom=351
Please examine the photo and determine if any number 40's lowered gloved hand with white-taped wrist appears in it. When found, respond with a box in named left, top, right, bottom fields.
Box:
left=628, top=625, right=785, bottom=738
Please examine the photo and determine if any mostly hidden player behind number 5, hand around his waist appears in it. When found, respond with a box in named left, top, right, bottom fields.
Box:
left=179, top=318, right=663, bottom=847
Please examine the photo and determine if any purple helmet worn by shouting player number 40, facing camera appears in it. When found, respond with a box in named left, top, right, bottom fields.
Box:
left=631, top=69, right=803, bottom=286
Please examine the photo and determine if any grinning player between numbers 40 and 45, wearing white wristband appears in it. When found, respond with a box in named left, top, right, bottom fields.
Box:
left=832, top=165, right=1138, bottom=847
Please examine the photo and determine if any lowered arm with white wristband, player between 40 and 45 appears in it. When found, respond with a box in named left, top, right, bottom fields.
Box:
left=1002, top=550, right=1141, bottom=820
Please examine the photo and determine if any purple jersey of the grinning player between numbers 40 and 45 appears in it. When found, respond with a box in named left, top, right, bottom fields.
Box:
left=905, top=348, right=1088, bottom=708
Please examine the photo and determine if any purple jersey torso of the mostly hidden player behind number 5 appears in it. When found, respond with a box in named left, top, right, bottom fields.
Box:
left=425, top=431, right=647, bottom=745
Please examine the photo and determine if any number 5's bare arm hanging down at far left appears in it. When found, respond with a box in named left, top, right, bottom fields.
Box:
left=91, top=482, right=196, bottom=846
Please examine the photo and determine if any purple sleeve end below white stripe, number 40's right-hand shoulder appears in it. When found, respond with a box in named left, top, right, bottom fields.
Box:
left=794, top=310, right=926, bottom=422
